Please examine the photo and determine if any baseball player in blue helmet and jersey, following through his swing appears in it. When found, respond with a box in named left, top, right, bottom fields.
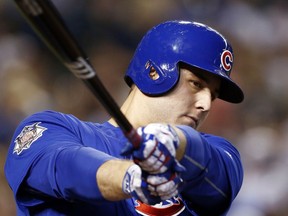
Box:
left=5, top=21, right=244, bottom=216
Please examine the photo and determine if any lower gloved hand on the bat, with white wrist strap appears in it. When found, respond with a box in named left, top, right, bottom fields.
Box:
left=122, top=164, right=182, bottom=205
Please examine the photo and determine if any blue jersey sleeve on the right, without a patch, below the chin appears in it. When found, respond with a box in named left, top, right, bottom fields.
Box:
left=179, top=126, right=243, bottom=215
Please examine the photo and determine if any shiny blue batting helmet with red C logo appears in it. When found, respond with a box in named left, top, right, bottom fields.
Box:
left=125, top=21, right=244, bottom=103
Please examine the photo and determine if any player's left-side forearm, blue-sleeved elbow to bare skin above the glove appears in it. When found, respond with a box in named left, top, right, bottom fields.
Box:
left=27, top=146, right=133, bottom=203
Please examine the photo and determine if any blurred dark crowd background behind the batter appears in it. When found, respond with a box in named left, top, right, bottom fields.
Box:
left=0, top=0, right=288, bottom=216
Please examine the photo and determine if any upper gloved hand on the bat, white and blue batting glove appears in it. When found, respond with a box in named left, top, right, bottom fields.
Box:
left=129, top=123, right=185, bottom=174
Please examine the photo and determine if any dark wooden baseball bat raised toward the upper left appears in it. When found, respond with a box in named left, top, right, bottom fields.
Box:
left=15, top=0, right=141, bottom=148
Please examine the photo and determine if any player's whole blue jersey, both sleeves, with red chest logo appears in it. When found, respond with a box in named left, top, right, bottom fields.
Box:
left=5, top=111, right=243, bottom=216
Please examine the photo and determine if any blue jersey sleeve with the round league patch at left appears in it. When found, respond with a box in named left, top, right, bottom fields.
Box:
left=5, top=112, right=113, bottom=205
